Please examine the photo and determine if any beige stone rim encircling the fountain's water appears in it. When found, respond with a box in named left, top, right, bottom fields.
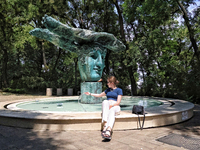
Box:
left=0, top=96, right=194, bottom=131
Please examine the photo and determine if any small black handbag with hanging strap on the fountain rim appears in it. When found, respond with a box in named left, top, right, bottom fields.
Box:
left=132, top=105, right=145, bottom=130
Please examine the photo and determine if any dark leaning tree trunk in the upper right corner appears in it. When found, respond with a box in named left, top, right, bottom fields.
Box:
left=177, top=0, right=200, bottom=64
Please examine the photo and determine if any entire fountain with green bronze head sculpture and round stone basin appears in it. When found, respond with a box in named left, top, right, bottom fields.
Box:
left=0, top=15, right=194, bottom=131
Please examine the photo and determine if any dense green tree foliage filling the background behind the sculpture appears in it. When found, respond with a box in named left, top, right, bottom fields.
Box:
left=0, top=0, right=200, bottom=103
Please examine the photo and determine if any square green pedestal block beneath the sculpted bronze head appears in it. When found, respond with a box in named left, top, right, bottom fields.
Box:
left=81, top=82, right=102, bottom=104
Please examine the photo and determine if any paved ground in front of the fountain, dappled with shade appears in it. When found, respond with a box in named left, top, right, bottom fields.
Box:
left=0, top=95, right=200, bottom=150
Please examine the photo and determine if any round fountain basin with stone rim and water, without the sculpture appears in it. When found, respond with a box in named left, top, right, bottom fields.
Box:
left=0, top=96, right=194, bottom=131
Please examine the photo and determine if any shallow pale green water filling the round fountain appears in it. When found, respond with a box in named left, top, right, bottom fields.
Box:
left=7, top=97, right=163, bottom=113
